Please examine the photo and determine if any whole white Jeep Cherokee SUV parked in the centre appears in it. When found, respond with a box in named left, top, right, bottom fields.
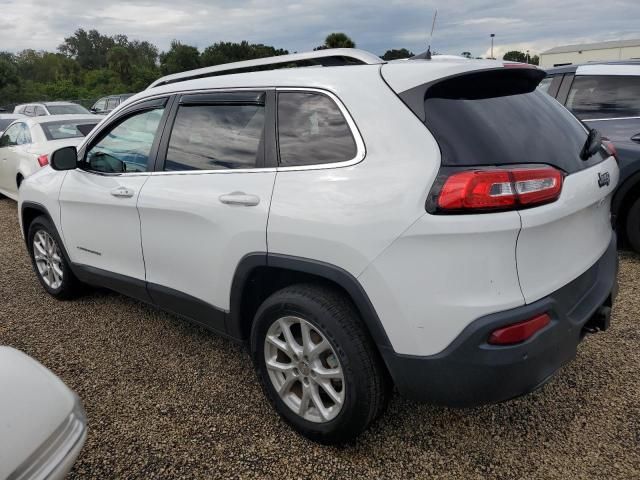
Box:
left=19, top=49, right=618, bottom=443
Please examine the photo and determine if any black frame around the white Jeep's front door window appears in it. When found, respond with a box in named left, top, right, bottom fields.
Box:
left=78, top=94, right=175, bottom=177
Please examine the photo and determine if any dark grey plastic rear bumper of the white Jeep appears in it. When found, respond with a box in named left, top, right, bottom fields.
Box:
left=381, top=235, right=618, bottom=407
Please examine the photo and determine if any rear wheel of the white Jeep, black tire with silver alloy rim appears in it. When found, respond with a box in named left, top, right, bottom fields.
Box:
left=251, top=285, right=389, bottom=444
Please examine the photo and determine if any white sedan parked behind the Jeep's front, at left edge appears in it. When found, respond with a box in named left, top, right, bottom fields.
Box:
left=0, top=114, right=103, bottom=200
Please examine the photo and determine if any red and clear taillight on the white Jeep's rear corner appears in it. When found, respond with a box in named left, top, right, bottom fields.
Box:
left=435, top=167, right=562, bottom=213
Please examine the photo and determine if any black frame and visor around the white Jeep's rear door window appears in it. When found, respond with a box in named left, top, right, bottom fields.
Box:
left=152, top=87, right=277, bottom=175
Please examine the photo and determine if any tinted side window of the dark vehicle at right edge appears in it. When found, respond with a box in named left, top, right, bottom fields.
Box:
left=567, top=75, right=640, bottom=120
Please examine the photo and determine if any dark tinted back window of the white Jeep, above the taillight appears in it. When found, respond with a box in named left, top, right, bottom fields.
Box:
left=424, top=69, right=597, bottom=173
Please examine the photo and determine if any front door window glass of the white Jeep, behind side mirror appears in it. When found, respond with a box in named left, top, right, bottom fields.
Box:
left=85, top=108, right=164, bottom=173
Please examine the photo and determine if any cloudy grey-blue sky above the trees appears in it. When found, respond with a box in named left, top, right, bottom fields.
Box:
left=0, top=0, right=640, bottom=58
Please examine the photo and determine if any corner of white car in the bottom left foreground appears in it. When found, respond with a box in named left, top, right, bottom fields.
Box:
left=0, top=347, right=87, bottom=480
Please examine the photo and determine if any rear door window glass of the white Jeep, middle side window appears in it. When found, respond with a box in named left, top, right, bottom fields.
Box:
left=164, top=104, right=265, bottom=171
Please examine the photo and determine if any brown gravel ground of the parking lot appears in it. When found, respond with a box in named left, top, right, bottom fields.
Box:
left=0, top=199, right=640, bottom=479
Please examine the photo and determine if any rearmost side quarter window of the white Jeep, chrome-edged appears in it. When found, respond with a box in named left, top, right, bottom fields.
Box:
left=278, top=92, right=357, bottom=167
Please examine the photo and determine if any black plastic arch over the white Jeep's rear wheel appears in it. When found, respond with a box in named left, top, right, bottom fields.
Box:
left=227, top=252, right=391, bottom=349
